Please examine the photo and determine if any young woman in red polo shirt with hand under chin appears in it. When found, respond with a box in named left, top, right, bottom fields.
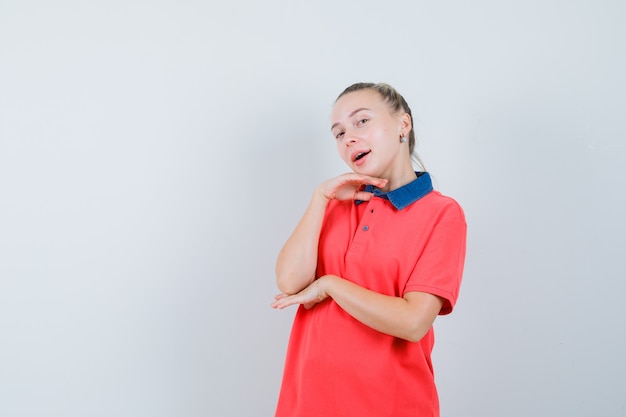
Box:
left=272, top=83, right=466, bottom=417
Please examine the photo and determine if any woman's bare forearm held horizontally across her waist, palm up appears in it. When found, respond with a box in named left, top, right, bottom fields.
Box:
left=272, top=275, right=443, bottom=342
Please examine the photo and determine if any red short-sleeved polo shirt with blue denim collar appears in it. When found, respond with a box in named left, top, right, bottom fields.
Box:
left=276, top=173, right=466, bottom=417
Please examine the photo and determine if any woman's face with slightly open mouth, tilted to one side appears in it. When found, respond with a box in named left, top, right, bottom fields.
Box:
left=331, top=89, right=410, bottom=178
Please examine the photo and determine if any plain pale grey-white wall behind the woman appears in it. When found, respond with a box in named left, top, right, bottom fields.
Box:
left=0, top=0, right=626, bottom=417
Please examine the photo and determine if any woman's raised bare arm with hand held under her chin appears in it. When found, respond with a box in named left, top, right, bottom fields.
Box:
left=276, top=173, right=387, bottom=294
